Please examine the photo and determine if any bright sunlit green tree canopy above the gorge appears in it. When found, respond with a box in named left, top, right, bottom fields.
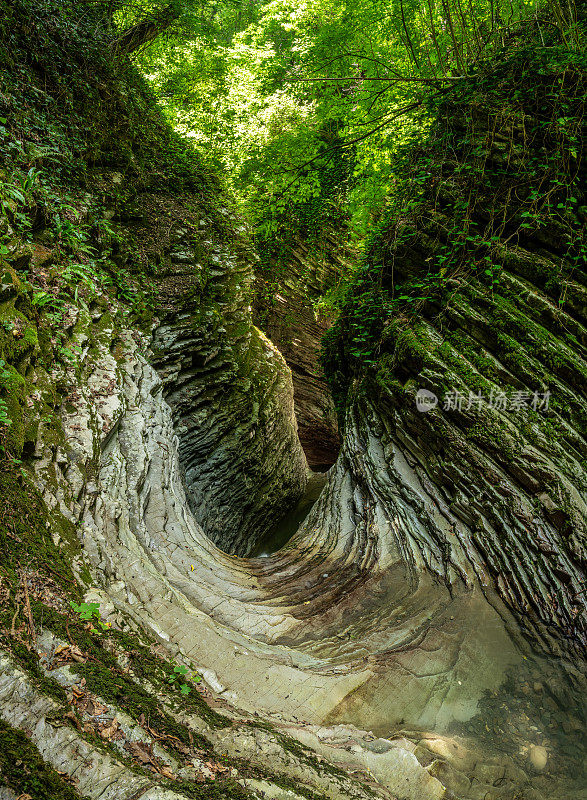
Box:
left=94, top=0, right=581, bottom=282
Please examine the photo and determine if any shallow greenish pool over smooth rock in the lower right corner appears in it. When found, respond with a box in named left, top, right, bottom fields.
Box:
left=320, top=580, right=587, bottom=800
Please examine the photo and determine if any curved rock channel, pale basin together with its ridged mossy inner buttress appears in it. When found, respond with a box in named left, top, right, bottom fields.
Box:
left=23, top=220, right=581, bottom=800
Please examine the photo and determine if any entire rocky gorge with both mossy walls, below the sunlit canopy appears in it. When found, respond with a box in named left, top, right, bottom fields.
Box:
left=0, top=0, right=587, bottom=800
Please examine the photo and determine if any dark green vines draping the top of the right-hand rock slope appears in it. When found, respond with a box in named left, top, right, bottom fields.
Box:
left=324, top=34, right=587, bottom=408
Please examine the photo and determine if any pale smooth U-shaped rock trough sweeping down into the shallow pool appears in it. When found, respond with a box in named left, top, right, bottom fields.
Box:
left=24, top=310, right=584, bottom=800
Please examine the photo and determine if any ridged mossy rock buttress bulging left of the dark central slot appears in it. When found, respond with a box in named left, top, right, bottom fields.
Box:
left=113, top=194, right=307, bottom=555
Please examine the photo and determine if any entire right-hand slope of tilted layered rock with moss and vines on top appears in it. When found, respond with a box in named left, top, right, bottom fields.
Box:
left=325, top=31, right=587, bottom=647
